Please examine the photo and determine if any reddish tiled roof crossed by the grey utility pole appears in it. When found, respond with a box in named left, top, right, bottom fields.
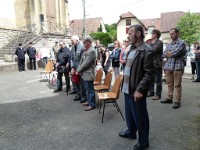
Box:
left=70, top=17, right=102, bottom=37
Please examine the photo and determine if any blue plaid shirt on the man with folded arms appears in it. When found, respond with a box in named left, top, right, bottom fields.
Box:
left=163, top=39, right=186, bottom=70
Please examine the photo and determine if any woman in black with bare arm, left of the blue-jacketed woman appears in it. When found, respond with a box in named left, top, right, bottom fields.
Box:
left=100, top=47, right=111, bottom=75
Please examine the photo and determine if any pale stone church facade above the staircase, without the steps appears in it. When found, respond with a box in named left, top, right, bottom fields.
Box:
left=0, top=0, right=69, bottom=33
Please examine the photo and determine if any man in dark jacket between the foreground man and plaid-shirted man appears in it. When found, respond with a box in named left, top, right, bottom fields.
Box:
left=148, top=29, right=163, bottom=100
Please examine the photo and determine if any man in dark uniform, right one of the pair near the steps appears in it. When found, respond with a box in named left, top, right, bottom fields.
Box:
left=26, top=42, right=36, bottom=70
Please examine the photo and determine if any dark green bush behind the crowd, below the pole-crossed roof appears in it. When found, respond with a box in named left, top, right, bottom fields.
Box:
left=90, top=32, right=112, bottom=46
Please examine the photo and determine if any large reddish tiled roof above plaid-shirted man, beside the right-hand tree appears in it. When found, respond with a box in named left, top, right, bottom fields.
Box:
left=160, top=11, right=185, bottom=32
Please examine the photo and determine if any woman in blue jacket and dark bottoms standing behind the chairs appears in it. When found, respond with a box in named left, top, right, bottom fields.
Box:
left=110, top=40, right=121, bottom=77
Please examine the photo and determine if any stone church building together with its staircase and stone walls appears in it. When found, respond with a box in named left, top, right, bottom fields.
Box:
left=0, top=0, right=69, bottom=59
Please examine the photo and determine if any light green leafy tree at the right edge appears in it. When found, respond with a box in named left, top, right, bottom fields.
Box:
left=177, top=12, right=200, bottom=45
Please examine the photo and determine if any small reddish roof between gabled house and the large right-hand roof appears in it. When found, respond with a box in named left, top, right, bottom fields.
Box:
left=141, top=18, right=160, bottom=30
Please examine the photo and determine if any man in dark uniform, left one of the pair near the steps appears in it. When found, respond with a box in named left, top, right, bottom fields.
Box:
left=15, top=43, right=26, bottom=72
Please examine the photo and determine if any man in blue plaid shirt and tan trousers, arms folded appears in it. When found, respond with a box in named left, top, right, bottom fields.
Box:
left=160, top=28, right=186, bottom=109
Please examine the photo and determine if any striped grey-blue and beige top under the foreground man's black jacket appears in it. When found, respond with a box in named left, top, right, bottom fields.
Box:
left=122, top=49, right=136, bottom=94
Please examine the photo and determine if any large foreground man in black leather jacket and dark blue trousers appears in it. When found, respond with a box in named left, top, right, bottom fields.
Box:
left=119, top=24, right=155, bottom=150
